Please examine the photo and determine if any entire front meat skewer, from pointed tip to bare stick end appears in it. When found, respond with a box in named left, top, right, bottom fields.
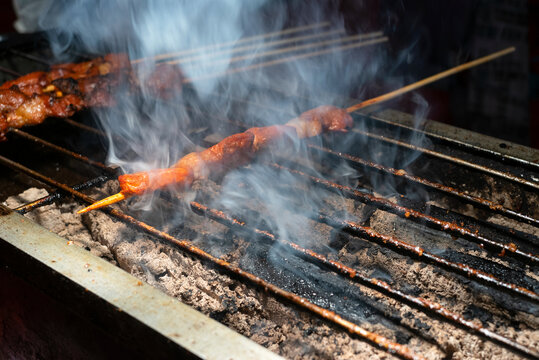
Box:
left=78, top=47, right=515, bottom=214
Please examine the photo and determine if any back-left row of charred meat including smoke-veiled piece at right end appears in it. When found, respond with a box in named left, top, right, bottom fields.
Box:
left=0, top=54, right=183, bottom=140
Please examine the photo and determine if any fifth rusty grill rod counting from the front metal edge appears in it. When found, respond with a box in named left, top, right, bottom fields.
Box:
left=307, top=143, right=539, bottom=226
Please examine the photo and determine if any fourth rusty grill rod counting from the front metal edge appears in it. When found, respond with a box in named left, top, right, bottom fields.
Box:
left=271, top=164, right=539, bottom=264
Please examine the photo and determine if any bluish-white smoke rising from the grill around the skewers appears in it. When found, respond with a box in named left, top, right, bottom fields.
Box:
left=30, top=0, right=430, bottom=260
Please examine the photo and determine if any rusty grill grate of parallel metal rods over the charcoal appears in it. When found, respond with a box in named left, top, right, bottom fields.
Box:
left=0, top=33, right=539, bottom=358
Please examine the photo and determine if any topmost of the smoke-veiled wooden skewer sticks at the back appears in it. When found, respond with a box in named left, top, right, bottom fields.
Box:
left=131, top=21, right=330, bottom=64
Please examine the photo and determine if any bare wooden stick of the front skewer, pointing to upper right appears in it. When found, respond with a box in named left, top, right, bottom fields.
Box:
left=346, top=47, right=515, bottom=113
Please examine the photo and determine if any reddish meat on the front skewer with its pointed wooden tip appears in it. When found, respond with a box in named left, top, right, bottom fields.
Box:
left=79, top=105, right=353, bottom=213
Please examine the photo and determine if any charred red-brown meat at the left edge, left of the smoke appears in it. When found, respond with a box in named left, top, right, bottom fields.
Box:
left=0, top=54, right=129, bottom=140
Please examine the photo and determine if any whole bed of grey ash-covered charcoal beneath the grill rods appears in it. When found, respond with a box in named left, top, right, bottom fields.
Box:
left=8, top=183, right=539, bottom=359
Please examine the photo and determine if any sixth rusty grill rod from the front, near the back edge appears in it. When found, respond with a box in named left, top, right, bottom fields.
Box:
left=350, top=128, right=539, bottom=190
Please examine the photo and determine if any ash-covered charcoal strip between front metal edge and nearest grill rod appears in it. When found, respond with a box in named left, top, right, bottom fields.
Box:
left=6, top=184, right=387, bottom=359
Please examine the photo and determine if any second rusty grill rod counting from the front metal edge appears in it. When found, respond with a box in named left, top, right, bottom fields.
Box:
left=190, top=201, right=539, bottom=357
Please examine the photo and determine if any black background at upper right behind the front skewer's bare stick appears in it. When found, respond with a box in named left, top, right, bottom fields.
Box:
left=0, top=0, right=539, bottom=148
